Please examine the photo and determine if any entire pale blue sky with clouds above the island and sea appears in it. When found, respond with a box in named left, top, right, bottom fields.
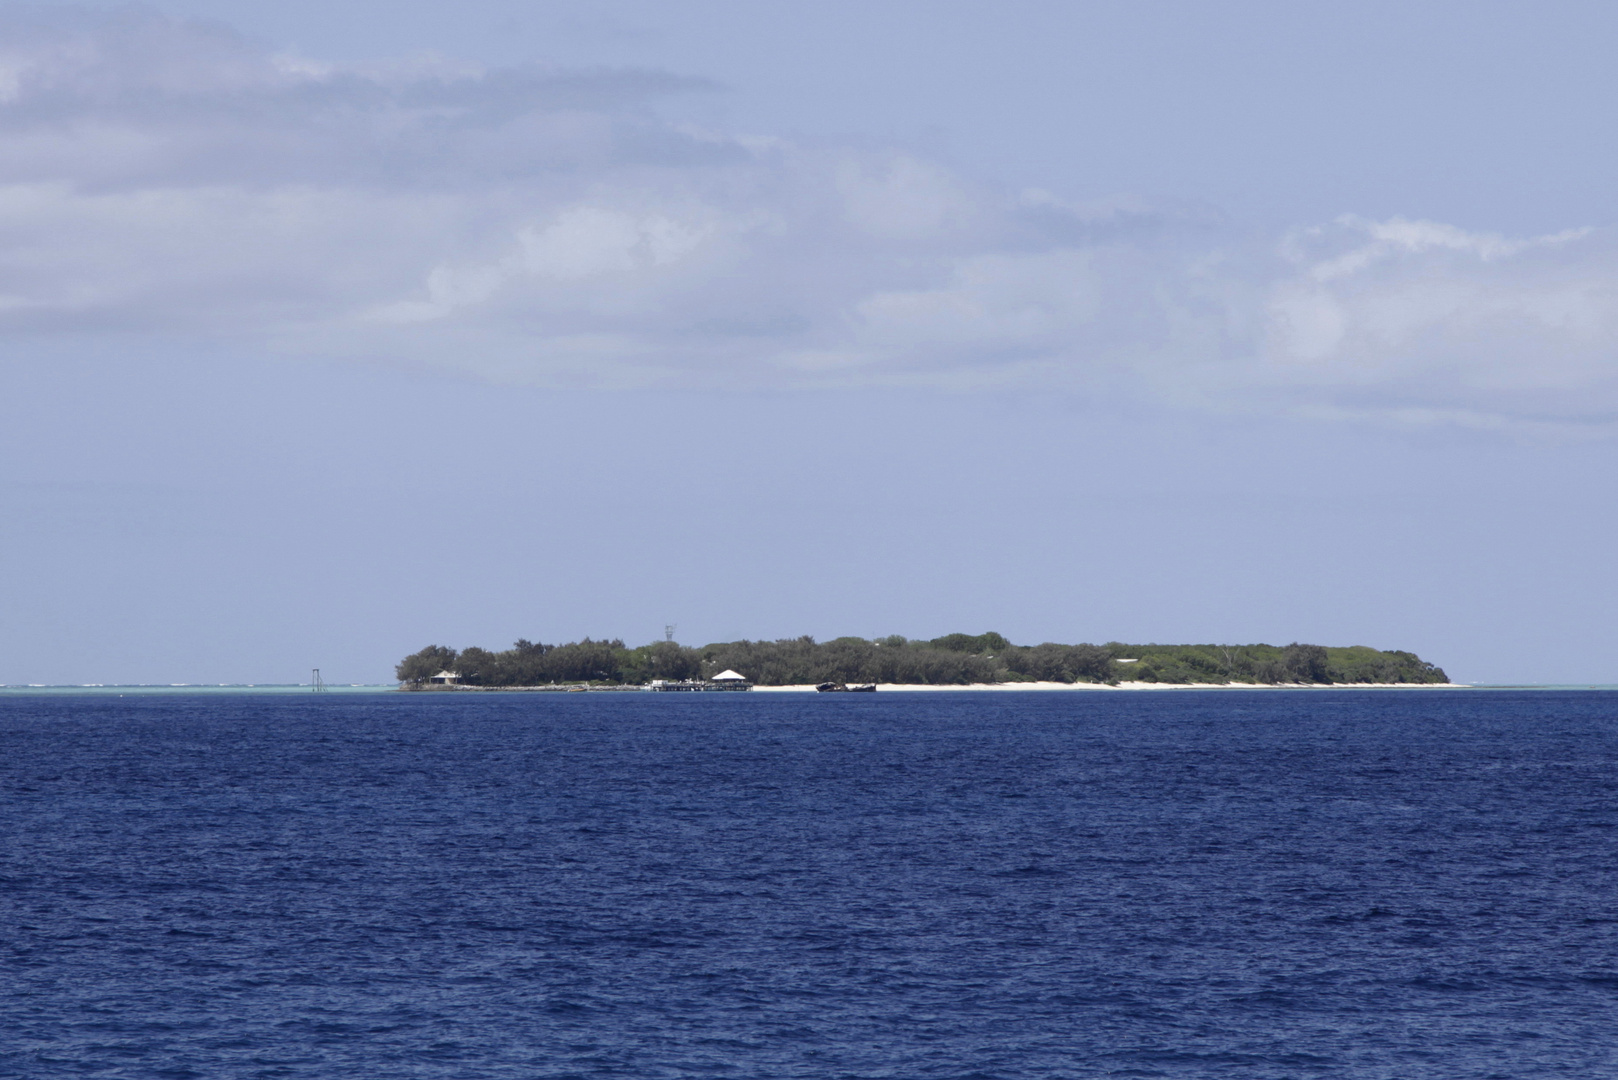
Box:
left=0, top=0, right=1618, bottom=685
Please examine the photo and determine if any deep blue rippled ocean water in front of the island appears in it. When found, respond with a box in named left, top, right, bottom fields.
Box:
left=0, top=691, right=1618, bottom=1080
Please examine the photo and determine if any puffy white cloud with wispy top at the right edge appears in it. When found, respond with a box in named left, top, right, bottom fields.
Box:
left=1264, top=219, right=1618, bottom=423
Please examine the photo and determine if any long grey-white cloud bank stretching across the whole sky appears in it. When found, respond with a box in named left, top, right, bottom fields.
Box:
left=0, top=13, right=1618, bottom=429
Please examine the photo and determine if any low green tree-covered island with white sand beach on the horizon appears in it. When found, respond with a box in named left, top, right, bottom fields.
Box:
left=395, top=633, right=1448, bottom=687
